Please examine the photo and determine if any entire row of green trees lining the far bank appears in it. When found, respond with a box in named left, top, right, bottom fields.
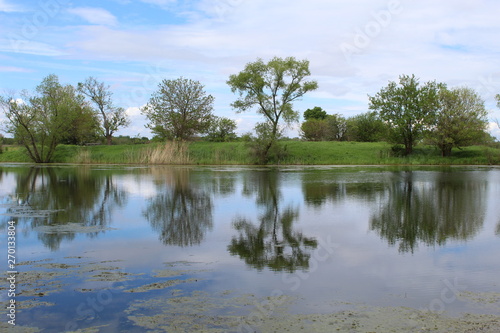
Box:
left=0, top=57, right=500, bottom=163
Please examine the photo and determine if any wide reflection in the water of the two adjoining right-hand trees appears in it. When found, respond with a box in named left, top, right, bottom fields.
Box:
left=370, top=171, right=487, bottom=253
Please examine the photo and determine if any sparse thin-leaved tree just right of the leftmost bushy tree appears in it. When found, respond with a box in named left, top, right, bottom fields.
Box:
left=78, top=76, right=130, bottom=145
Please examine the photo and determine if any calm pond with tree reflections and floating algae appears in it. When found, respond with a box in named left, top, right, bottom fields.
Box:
left=0, top=164, right=500, bottom=332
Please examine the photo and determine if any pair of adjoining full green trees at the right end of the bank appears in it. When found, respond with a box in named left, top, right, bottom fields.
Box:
left=369, top=75, right=488, bottom=156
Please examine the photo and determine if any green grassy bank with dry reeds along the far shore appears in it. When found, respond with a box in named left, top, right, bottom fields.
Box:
left=0, top=141, right=500, bottom=165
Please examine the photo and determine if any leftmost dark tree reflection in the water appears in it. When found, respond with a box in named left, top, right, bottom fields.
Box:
left=2, top=166, right=126, bottom=251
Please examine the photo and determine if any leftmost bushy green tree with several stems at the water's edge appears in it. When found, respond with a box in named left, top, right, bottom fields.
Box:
left=0, top=75, right=88, bottom=163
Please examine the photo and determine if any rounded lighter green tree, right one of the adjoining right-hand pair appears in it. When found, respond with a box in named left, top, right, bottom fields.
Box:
left=430, top=87, right=488, bottom=156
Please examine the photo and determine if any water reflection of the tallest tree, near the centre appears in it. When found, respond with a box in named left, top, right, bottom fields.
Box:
left=228, top=170, right=317, bottom=272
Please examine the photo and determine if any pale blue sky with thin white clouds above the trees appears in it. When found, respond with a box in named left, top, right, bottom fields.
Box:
left=0, top=0, right=500, bottom=138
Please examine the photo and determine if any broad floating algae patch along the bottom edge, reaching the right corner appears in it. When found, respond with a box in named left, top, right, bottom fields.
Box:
left=125, top=291, right=500, bottom=333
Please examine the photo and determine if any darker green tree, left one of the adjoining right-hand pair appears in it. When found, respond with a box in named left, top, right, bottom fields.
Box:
left=369, top=75, right=440, bottom=154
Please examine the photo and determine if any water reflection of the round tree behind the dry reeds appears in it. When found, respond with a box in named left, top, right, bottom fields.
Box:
left=143, top=168, right=212, bottom=246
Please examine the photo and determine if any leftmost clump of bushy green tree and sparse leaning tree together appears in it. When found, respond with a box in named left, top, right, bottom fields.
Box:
left=0, top=75, right=129, bottom=163
